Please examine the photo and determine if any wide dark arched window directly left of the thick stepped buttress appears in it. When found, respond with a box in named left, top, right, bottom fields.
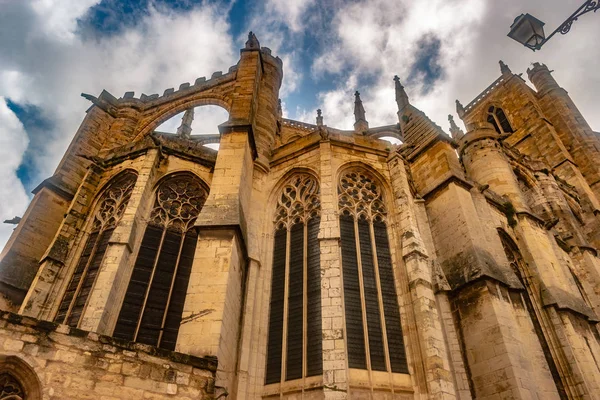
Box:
left=113, top=173, right=208, bottom=350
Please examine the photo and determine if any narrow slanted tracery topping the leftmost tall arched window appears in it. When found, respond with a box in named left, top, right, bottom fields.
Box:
left=92, top=171, right=137, bottom=232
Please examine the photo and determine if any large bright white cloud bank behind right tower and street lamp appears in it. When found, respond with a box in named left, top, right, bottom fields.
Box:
left=292, top=0, right=600, bottom=134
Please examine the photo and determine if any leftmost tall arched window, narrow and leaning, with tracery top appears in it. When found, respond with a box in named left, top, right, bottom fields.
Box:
left=54, top=171, right=137, bottom=327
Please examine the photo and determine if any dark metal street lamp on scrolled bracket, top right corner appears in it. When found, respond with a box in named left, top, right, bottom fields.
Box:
left=508, top=0, right=600, bottom=51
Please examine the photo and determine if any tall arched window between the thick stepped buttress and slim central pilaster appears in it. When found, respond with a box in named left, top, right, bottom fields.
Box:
left=265, top=173, right=323, bottom=384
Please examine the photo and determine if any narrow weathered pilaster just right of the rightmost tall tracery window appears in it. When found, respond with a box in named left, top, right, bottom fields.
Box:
left=388, top=154, right=456, bottom=399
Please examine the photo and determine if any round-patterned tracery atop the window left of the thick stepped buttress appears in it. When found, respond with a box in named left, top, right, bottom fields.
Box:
left=150, top=174, right=208, bottom=232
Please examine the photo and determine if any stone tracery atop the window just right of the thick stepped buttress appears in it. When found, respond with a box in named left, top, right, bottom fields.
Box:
left=275, top=173, right=321, bottom=229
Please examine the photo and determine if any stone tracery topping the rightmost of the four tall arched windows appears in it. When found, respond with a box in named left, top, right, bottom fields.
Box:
left=338, top=169, right=387, bottom=221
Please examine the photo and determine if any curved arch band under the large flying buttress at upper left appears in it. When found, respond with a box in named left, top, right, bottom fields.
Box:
left=134, top=93, right=232, bottom=141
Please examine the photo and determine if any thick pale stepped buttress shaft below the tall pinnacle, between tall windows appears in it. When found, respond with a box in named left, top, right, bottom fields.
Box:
left=176, top=128, right=254, bottom=395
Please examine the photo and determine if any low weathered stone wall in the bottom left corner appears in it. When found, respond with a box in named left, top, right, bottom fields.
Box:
left=0, top=312, right=217, bottom=400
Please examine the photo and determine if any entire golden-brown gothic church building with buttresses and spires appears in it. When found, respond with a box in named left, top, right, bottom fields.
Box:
left=0, top=34, right=600, bottom=400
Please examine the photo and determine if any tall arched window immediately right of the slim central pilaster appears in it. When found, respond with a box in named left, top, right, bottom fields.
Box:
left=338, top=168, right=408, bottom=373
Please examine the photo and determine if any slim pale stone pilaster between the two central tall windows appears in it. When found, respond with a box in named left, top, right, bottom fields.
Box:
left=319, top=140, right=349, bottom=399
